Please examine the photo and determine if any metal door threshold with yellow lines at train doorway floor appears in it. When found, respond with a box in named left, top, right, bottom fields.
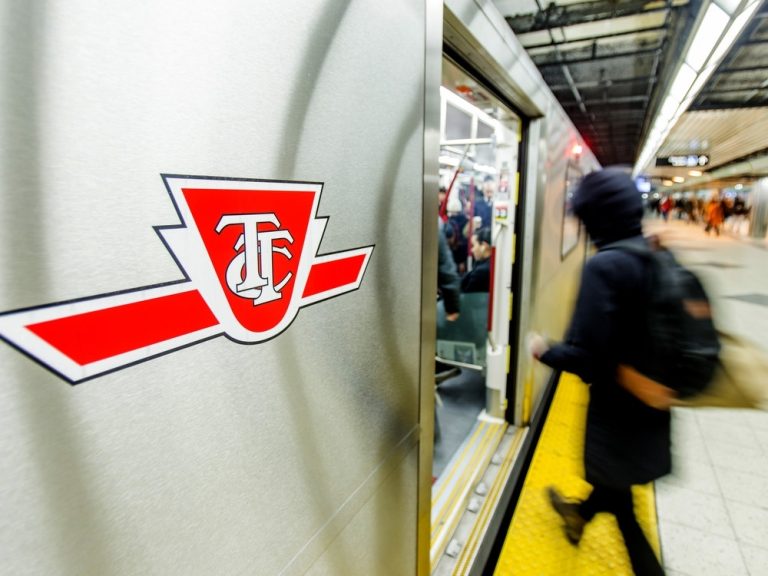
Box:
left=430, top=412, right=528, bottom=576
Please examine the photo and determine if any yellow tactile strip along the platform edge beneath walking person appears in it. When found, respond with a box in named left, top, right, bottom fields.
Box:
left=494, top=374, right=659, bottom=576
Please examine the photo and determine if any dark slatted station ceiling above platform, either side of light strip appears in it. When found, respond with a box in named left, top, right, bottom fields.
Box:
left=494, top=0, right=768, bottom=186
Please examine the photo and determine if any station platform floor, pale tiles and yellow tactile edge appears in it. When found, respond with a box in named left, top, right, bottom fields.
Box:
left=493, top=220, right=768, bottom=576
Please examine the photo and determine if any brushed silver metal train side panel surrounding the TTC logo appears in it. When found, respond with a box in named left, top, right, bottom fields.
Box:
left=0, top=0, right=425, bottom=575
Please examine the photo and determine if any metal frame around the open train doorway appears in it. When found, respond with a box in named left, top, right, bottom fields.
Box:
left=417, top=0, right=552, bottom=575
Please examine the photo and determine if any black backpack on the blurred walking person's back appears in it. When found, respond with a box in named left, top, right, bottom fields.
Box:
left=603, top=240, right=720, bottom=398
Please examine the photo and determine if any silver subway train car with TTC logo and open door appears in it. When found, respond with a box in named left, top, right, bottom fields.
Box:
left=0, top=0, right=598, bottom=576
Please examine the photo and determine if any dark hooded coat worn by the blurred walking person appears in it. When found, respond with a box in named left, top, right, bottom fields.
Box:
left=541, top=169, right=671, bottom=488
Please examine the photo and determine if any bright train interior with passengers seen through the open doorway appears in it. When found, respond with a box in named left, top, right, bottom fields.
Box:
left=431, top=57, right=521, bottom=571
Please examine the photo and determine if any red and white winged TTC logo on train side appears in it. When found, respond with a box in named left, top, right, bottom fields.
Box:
left=0, top=175, right=373, bottom=384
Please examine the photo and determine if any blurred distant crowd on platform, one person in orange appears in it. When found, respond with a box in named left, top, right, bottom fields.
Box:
left=648, top=193, right=750, bottom=236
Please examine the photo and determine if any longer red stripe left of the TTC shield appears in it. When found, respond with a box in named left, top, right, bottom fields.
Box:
left=27, top=290, right=218, bottom=366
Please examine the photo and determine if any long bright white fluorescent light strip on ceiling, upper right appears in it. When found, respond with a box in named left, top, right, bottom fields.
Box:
left=632, top=0, right=760, bottom=176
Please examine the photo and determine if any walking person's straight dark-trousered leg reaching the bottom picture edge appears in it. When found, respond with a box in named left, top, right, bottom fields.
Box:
left=601, top=488, right=664, bottom=576
